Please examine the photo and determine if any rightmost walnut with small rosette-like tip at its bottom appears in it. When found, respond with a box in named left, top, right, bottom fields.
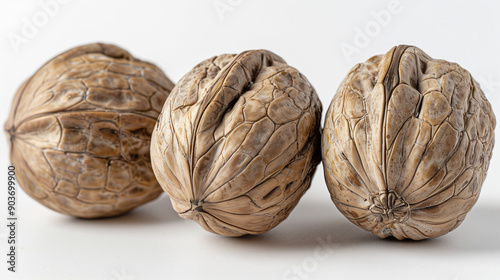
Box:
left=322, top=46, right=495, bottom=240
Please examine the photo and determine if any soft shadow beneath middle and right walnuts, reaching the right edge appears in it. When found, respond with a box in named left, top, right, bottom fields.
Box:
left=211, top=201, right=500, bottom=253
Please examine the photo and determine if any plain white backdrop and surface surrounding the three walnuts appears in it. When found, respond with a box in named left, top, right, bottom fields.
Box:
left=0, top=0, right=500, bottom=280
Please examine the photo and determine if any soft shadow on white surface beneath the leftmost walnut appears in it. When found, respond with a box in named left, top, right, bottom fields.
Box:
left=57, top=194, right=180, bottom=226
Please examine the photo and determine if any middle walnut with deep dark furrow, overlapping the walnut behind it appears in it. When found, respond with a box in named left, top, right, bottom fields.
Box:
left=151, top=50, right=321, bottom=236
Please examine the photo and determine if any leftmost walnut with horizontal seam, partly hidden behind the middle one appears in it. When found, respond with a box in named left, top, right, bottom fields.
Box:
left=5, top=44, right=174, bottom=218
